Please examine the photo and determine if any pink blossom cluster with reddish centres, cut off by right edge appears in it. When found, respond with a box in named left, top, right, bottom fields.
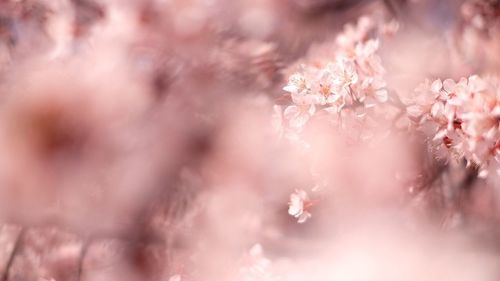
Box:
left=407, top=75, right=500, bottom=177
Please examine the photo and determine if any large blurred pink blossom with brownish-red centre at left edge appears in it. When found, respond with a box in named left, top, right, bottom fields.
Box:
left=0, top=61, right=156, bottom=231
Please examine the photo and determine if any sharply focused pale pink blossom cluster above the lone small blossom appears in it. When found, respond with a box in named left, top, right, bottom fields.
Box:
left=283, top=18, right=388, bottom=135
